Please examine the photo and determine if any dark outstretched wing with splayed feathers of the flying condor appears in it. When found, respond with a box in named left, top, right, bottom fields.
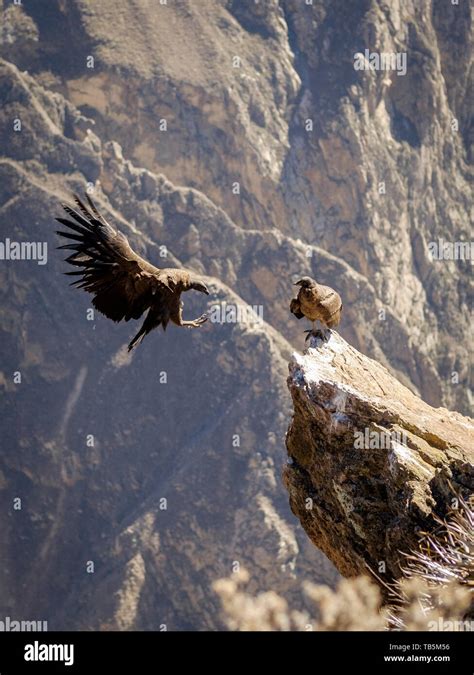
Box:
left=56, top=195, right=172, bottom=321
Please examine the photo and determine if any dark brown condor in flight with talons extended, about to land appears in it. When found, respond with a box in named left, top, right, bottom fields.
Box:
left=56, top=195, right=209, bottom=351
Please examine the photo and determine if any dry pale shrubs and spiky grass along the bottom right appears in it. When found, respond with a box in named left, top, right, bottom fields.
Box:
left=214, top=500, right=474, bottom=631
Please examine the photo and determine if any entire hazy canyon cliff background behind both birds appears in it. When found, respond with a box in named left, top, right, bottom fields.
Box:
left=0, top=0, right=470, bottom=629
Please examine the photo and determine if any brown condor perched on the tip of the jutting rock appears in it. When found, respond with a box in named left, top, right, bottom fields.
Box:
left=290, top=277, right=342, bottom=332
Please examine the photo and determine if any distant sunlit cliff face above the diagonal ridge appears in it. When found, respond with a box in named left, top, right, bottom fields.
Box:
left=3, top=0, right=472, bottom=412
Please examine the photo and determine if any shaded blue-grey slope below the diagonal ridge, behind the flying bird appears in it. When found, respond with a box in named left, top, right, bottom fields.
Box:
left=0, top=61, right=337, bottom=630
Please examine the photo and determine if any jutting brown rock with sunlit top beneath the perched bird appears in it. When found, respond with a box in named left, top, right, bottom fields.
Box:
left=284, top=332, right=474, bottom=582
